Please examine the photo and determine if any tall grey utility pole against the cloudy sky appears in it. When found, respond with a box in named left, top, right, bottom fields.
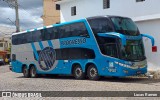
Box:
left=15, top=0, right=20, bottom=32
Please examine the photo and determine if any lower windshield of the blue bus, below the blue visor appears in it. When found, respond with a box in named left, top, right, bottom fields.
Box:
left=121, top=40, right=146, bottom=61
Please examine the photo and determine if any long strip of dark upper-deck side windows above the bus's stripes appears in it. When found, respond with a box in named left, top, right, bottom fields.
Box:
left=12, top=23, right=89, bottom=45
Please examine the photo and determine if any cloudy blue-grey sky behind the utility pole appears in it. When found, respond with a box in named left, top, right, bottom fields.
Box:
left=0, top=0, right=43, bottom=33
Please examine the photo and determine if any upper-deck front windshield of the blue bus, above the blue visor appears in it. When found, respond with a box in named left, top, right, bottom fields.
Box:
left=111, top=17, right=140, bottom=36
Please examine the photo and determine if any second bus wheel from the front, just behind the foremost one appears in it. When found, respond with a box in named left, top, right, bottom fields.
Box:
left=73, top=64, right=85, bottom=80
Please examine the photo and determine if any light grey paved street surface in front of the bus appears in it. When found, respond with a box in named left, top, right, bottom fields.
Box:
left=0, top=66, right=160, bottom=100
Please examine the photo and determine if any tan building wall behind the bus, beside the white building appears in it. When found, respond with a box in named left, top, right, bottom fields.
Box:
left=42, top=0, right=60, bottom=26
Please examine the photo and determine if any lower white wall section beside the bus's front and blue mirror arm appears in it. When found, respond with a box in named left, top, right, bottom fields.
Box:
left=137, top=19, right=160, bottom=70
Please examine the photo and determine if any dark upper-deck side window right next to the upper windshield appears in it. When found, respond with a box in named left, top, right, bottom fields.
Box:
left=88, top=18, right=113, bottom=34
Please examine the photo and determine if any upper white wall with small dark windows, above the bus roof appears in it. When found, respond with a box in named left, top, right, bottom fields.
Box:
left=61, top=0, right=160, bottom=22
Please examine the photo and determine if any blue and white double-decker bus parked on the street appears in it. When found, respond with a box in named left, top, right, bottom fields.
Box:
left=11, top=16, right=154, bottom=80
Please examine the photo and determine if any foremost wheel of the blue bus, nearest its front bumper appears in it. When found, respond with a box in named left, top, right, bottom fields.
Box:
left=87, top=64, right=100, bottom=80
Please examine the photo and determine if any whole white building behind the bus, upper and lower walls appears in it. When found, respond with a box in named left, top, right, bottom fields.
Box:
left=55, top=0, right=160, bottom=69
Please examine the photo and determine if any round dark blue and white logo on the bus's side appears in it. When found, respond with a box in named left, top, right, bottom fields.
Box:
left=38, top=47, right=56, bottom=71
